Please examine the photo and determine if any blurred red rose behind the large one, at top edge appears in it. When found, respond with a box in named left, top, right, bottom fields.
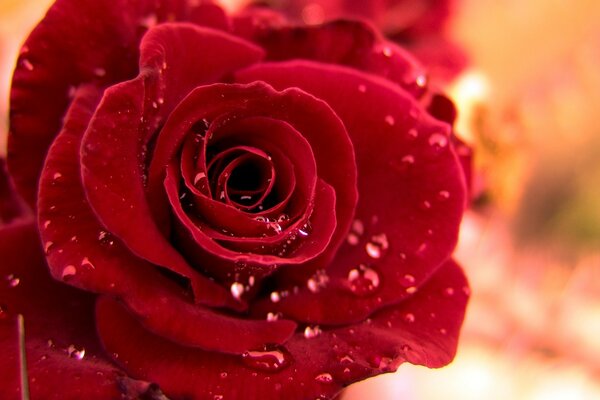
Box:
left=253, top=0, right=467, bottom=82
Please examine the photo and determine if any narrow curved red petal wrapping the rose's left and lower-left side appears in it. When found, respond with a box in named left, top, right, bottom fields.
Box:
left=38, top=87, right=295, bottom=353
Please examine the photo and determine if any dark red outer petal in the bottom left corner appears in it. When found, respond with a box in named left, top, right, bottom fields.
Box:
left=0, top=223, right=124, bottom=400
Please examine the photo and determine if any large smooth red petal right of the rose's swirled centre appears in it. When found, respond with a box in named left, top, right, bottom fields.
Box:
left=237, top=61, right=465, bottom=324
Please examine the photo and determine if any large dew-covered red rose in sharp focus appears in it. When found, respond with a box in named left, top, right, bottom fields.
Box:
left=0, top=0, right=468, bottom=399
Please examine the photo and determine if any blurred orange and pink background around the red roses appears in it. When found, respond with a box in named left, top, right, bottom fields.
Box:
left=0, top=0, right=600, bottom=400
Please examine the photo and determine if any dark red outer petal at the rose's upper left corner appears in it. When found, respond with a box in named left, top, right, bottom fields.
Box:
left=8, top=0, right=227, bottom=206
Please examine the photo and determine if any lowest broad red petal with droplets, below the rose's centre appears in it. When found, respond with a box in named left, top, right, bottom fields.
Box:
left=97, top=262, right=468, bottom=400
